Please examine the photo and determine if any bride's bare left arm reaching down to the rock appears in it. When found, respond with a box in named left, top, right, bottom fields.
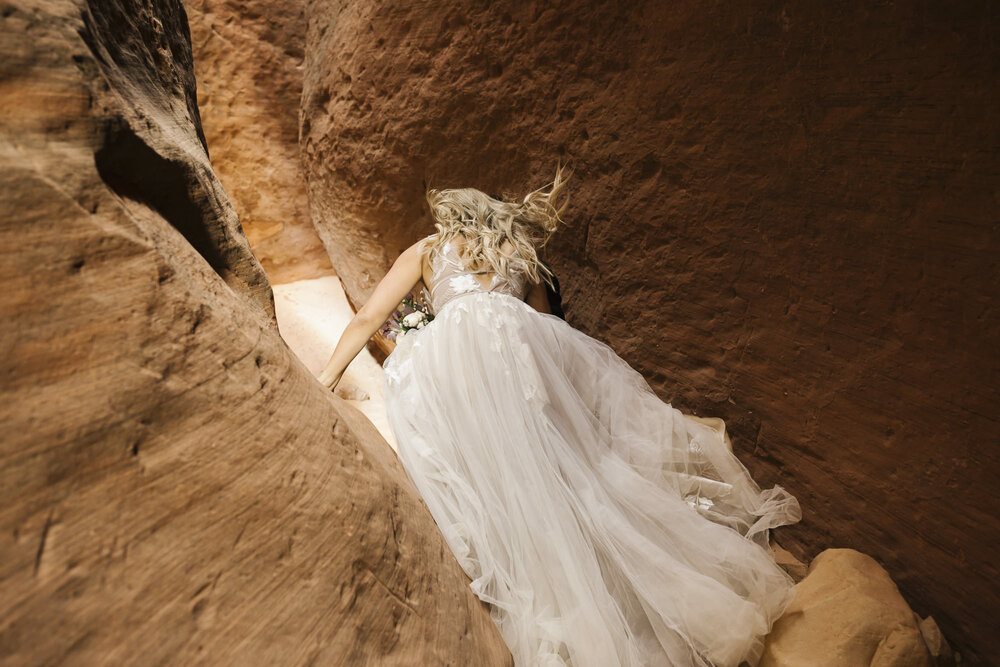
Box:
left=317, top=242, right=421, bottom=389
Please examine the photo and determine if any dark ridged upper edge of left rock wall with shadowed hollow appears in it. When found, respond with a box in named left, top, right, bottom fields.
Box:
left=79, top=0, right=274, bottom=321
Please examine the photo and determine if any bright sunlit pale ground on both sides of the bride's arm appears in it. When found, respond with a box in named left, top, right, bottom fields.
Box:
left=273, top=276, right=396, bottom=449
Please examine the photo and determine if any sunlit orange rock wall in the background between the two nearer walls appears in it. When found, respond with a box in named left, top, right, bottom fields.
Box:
left=184, top=0, right=333, bottom=283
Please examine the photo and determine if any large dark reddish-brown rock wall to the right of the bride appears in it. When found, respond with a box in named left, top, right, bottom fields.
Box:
left=300, top=0, right=1000, bottom=662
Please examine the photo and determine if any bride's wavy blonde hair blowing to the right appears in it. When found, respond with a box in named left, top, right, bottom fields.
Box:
left=420, top=165, right=573, bottom=285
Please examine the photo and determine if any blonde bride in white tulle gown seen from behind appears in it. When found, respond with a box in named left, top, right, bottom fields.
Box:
left=319, top=168, right=800, bottom=667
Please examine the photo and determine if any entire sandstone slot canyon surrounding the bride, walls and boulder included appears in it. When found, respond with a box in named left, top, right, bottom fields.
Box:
left=0, top=0, right=1000, bottom=666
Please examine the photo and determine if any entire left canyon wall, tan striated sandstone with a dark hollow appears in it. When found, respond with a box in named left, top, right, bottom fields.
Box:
left=0, top=0, right=510, bottom=665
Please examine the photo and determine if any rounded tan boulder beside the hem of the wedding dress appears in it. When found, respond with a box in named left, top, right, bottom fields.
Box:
left=760, top=549, right=932, bottom=667
